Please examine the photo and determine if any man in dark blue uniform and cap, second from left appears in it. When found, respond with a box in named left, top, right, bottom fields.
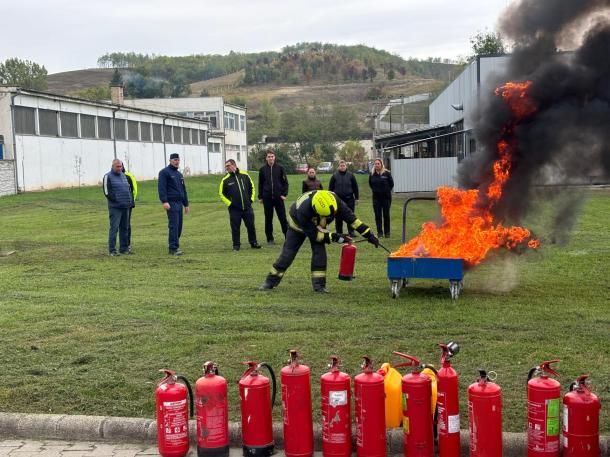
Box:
left=158, top=153, right=189, bottom=255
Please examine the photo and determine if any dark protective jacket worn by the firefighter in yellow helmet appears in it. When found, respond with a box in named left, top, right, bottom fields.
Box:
left=288, top=190, right=371, bottom=243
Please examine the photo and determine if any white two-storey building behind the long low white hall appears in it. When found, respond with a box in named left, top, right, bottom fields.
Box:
left=125, top=97, right=248, bottom=173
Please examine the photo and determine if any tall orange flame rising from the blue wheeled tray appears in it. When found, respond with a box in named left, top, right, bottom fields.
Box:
left=391, top=81, right=540, bottom=266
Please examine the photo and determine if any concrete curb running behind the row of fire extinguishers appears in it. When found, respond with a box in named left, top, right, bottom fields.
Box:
left=0, top=413, right=610, bottom=457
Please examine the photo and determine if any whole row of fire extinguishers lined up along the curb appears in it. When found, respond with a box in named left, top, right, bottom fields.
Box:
left=156, top=342, right=600, bottom=457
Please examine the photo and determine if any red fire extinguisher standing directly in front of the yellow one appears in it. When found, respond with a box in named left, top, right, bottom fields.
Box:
left=393, top=351, right=434, bottom=457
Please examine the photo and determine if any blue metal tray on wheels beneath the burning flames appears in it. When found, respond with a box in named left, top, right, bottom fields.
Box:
left=388, top=257, right=464, bottom=300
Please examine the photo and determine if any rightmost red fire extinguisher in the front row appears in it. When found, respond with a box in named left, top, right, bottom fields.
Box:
left=562, top=375, right=601, bottom=457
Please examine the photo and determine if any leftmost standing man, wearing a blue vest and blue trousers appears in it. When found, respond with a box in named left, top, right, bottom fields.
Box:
left=102, top=159, right=133, bottom=256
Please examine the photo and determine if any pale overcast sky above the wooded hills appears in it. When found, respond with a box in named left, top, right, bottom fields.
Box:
left=0, top=0, right=510, bottom=73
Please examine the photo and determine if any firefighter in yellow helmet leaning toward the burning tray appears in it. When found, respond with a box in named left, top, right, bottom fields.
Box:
left=260, top=190, right=379, bottom=293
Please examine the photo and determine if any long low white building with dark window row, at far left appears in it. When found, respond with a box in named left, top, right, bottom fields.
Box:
left=0, top=87, right=210, bottom=195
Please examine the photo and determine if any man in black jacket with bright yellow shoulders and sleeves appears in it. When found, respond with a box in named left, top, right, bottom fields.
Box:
left=218, top=159, right=261, bottom=251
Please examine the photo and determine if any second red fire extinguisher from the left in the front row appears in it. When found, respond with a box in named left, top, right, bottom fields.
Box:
left=195, top=362, right=229, bottom=457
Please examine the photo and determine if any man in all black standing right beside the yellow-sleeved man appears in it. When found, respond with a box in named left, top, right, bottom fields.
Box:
left=258, top=149, right=288, bottom=244
